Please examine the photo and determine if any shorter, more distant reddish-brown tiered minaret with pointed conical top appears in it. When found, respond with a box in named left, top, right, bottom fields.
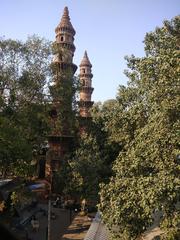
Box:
left=79, top=51, right=94, bottom=132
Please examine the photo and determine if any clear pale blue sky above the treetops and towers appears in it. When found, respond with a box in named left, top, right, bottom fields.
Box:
left=0, top=0, right=180, bottom=101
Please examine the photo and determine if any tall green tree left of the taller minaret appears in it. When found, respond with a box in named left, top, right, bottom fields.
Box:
left=0, top=36, right=51, bottom=177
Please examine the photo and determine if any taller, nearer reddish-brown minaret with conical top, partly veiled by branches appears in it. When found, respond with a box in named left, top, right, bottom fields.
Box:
left=48, top=7, right=77, bottom=177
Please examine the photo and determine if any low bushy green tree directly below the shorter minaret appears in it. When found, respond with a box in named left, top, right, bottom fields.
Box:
left=70, top=134, right=103, bottom=204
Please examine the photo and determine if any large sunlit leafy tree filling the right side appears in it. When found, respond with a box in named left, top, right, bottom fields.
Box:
left=99, top=16, right=180, bottom=239
